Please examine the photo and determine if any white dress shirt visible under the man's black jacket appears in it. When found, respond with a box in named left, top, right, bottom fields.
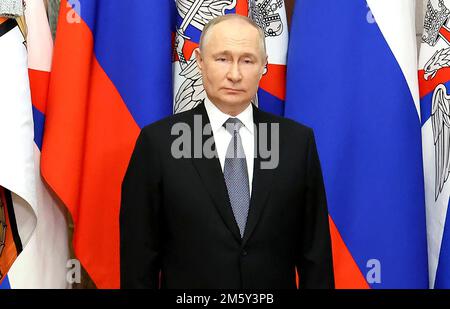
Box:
left=205, top=98, right=255, bottom=195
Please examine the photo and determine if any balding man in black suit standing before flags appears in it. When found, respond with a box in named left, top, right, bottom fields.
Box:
left=120, top=15, right=334, bottom=289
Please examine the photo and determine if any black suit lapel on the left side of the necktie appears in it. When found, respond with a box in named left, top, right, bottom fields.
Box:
left=191, top=104, right=241, bottom=243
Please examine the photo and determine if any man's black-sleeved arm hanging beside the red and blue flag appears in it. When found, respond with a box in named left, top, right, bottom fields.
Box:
left=120, top=131, right=161, bottom=289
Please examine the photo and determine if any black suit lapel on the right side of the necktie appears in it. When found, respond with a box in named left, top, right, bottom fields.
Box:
left=242, top=106, right=275, bottom=246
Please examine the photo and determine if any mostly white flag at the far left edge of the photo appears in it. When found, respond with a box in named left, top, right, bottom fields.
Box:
left=0, top=18, right=37, bottom=287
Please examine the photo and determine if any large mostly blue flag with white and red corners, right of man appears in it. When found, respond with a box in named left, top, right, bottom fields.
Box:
left=285, top=0, right=428, bottom=288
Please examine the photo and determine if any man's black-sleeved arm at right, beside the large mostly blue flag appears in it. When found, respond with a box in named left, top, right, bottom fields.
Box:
left=297, top=131, right=334, bottom=289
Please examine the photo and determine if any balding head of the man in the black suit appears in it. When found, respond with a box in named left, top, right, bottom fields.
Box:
left=195, top=14, right=267, bottom=115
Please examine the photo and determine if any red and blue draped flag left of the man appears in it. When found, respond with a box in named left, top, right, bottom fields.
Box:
left=41, top=0, right=175, bottom=288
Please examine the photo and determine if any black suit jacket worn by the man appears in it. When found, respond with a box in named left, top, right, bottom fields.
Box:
left=120, top=104, right=334, bottom=289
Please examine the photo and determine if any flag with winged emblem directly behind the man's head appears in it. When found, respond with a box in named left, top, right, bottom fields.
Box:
left=173, top=0, right=288, bottom=115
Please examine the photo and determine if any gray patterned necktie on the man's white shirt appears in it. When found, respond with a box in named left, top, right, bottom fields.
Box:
left=223, top=118, right=250, bottom=237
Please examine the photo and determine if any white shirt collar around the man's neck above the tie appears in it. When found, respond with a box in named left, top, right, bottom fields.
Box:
left=205, top=97, right=253, bottom=135
